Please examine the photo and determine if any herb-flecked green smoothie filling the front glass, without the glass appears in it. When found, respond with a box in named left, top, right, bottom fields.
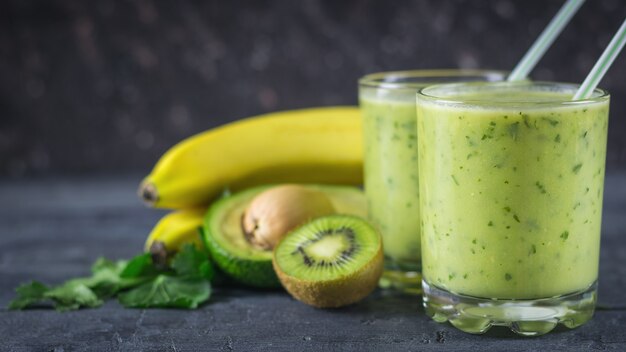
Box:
left=417, top=92, right=608, bottom=299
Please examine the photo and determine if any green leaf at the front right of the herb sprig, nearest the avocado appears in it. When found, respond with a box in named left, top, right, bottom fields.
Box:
left=118, top=275, right=211, bottom=309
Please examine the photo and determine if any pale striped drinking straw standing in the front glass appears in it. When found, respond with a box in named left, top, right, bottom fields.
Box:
left=572, top=20, right=626, bottom=100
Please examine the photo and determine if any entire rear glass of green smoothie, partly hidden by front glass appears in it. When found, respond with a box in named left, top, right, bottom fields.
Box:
left=359, top=70, right=506, bottom=292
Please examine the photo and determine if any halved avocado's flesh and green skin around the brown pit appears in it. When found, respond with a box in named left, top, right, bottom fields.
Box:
left=202, top=185, right=367, bottom=288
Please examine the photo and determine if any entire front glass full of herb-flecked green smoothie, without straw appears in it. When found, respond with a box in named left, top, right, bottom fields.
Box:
left=417, top=82, right=609, bottom=335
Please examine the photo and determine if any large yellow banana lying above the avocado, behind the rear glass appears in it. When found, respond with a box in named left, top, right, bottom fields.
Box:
left=138, top=107, right=363, bottom=209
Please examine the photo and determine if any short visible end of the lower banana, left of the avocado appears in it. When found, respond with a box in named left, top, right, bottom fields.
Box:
left=144, top=208, right=206, bottom=252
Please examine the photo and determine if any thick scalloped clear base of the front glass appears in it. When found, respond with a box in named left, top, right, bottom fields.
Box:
left=422, top=280, right=597, bottom=336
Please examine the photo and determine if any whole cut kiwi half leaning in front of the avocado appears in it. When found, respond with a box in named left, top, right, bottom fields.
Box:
left=273, top=215, right=383, bottom=308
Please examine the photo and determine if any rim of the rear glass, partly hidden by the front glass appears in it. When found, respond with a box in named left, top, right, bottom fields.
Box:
left=358, top=68, right=510, bottom=89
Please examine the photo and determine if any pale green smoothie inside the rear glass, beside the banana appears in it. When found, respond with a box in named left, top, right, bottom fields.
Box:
left=360, top=98, right=421, bottom=270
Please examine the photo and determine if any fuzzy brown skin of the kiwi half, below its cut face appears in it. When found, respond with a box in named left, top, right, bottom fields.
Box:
left=272, top=228, right=383, bottom=308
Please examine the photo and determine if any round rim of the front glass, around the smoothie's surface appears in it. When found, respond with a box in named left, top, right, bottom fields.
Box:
left=416, top=81, right=610, bottom=108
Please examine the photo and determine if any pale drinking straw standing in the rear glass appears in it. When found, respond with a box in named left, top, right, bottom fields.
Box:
left=507, top=0, right=585, bottom=81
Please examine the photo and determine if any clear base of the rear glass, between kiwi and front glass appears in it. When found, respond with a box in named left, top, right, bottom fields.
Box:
left=378, top=258, right=422, bottom=295
